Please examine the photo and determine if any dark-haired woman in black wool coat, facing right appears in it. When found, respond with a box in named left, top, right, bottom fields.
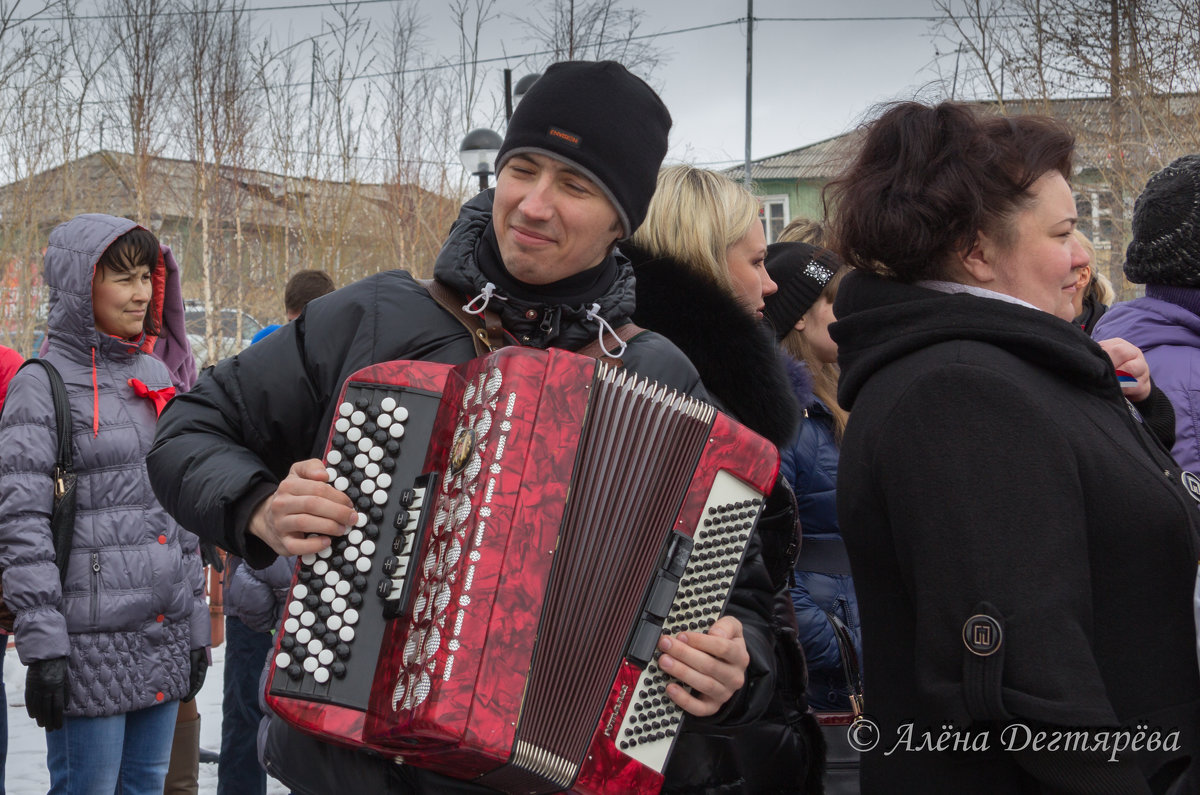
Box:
left=828, top=103, right=1200, bottom=793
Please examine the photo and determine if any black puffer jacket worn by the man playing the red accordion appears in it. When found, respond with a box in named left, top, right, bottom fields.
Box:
left=150, top=191, right=774, bottom=793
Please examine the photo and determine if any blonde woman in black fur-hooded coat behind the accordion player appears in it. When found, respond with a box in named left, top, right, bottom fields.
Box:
left=620, top=166, right=820, bottom=793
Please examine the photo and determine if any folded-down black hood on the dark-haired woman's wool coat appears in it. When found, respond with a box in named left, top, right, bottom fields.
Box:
left=829, top=271, right=1120, bottom=411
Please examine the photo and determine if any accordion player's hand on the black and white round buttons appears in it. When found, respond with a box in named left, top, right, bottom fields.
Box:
left=248, top=459, right=358, bottom=555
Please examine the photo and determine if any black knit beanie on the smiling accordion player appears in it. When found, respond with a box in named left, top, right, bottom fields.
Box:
left=496, top=61, right=671, bottom=238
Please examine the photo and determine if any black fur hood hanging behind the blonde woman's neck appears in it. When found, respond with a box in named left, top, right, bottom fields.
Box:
left=620, top=241, right=800, bottom=447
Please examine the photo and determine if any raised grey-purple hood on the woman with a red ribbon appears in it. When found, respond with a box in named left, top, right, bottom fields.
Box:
left=42, top=214, right=170, bottom=355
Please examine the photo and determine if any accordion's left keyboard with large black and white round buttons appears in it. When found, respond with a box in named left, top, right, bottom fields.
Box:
left=270, top=383, right=439, bottom=711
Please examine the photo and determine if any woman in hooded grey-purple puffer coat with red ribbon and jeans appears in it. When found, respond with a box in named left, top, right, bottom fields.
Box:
left=0, top=215, right=210, bottom=794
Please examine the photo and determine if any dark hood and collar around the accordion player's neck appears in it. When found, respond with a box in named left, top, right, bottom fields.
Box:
left=433, top=189, right=634, bottom=351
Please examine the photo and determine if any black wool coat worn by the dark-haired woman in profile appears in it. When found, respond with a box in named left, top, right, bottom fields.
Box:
left=830, top=273, right=1200, bottom=793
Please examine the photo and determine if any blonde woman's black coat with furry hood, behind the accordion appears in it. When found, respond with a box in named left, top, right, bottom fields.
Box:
left=622, top=243, right=824, bottom=793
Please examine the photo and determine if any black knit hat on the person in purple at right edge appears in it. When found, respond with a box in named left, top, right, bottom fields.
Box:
left=1124, top=155, right=1200, bottom=287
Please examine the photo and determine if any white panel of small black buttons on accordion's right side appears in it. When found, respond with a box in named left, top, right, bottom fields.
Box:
left=617, top=471, right=762, bottom=771
